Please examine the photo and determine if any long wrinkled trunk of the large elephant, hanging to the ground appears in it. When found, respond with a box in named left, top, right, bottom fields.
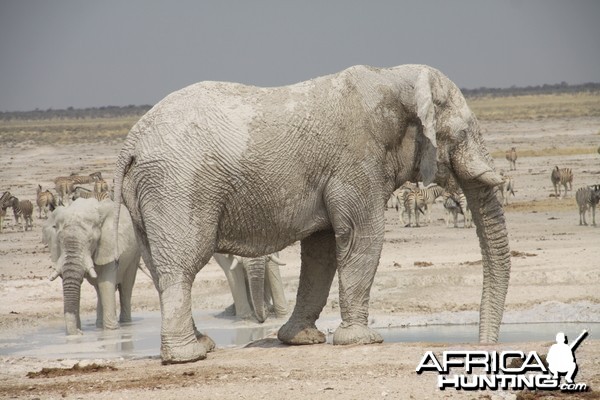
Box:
left=464, top=182, right=511, bottom=343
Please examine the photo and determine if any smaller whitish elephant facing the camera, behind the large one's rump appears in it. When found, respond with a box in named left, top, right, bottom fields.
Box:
left=43, top=199, right=140, bottom=335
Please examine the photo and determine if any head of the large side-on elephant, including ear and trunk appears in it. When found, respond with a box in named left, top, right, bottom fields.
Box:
left=407, top=68, right=511, bottom=342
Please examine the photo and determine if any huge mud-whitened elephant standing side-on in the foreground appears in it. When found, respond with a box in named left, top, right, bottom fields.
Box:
left=115, top=65, right=510, bottom=363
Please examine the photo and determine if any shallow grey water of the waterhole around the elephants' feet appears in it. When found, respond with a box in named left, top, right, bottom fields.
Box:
left=0, top=311, right=600, bottom=359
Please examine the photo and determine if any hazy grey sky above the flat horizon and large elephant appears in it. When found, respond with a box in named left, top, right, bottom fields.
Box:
left=0, top=0, right=600, bottom=111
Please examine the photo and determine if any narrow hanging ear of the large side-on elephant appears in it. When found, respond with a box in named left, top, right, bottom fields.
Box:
left=415, top=69, right=437, bottom=185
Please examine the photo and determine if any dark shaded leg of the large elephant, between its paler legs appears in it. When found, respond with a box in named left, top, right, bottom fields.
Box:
left=277, top=232, right=336, bottom=344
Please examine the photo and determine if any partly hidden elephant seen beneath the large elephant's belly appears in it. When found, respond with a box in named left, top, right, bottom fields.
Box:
left=214, top=253, right=287, bottom=323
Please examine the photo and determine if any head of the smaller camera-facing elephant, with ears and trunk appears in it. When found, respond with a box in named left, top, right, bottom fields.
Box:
left=43, top=199, right=123, bottom=335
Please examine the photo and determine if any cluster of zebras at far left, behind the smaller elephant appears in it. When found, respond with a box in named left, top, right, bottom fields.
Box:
left=0, top=172, right=112, bottom=233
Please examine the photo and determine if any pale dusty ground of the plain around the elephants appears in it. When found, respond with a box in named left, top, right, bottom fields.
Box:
left=0, top=118, right=600, bottom=399
